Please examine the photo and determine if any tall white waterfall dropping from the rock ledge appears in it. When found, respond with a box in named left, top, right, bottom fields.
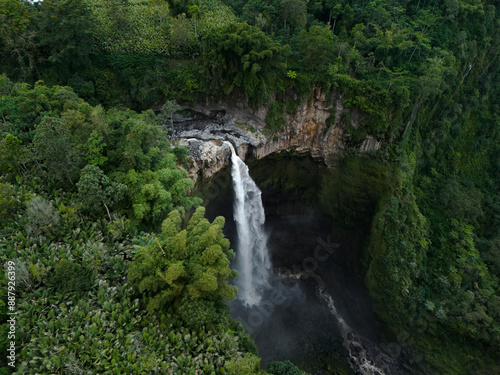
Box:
left=226, top=141, right=271, bottom=306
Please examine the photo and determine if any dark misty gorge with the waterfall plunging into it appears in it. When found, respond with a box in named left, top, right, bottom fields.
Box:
left=200, top=138, right=412, bottom=375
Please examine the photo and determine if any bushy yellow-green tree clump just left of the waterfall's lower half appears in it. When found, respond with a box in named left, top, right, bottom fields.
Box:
left=128, top=207, right=236, bottom=312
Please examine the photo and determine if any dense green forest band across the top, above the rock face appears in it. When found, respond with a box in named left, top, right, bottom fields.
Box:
left=0, top=0, right=498, bottom=140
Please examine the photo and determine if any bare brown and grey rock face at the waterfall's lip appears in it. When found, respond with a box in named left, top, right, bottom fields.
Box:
left=169, top=87, right=381, bottom=180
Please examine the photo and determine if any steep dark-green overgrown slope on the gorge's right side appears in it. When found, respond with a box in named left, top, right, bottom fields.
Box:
left=316, top=3, right=500, bottom=368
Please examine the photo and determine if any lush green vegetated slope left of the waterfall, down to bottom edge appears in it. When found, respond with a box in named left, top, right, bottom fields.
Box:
left=0, top=83, right=260, bottom=375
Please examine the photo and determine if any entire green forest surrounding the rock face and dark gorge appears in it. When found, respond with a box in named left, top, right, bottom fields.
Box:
left=0, top=0, right=500, bottom=375
